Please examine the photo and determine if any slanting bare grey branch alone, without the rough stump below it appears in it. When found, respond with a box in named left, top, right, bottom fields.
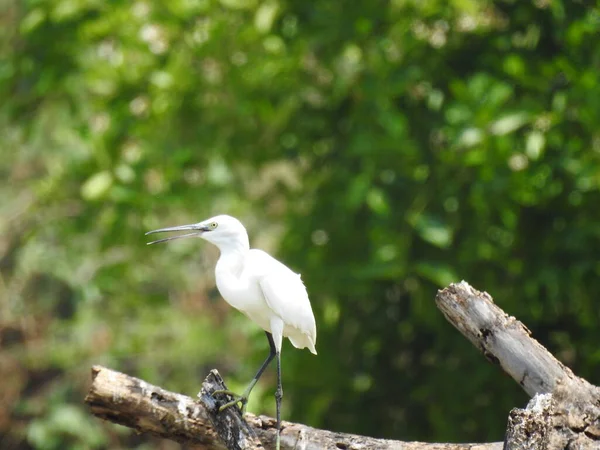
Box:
left=436, top=281, right=576, bottom=397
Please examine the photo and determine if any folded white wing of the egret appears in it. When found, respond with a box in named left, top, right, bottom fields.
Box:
left=250, top=250, right=317, bottom=346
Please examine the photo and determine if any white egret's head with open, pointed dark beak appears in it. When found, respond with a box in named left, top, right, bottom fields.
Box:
left=146, top=215, right=249, bottom=251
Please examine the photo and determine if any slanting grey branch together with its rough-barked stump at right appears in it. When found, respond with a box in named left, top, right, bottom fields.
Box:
left=436, top=281, right=600, bottom=450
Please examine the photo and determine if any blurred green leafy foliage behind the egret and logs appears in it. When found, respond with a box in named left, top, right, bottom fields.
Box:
left=0, top=0, right=600, bottom=450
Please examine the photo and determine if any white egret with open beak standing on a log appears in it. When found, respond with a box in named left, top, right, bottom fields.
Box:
left=146, top=215, right=317, bottom=449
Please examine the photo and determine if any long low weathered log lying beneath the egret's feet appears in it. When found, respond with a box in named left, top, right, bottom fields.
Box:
left=85, top=366, right=502, bottom=450
